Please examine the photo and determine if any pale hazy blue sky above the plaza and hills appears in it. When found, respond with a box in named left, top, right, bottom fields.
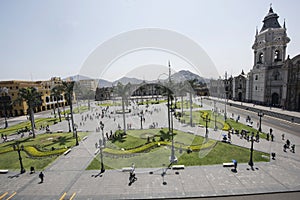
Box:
left=0, top=0, right=300, bottom=81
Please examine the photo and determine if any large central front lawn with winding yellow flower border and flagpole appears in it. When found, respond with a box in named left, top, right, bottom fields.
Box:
left=87, top=129, right=269, bottom=170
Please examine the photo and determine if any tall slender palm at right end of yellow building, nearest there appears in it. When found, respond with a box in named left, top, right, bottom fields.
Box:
left=62, top=81, right=78, bottom=145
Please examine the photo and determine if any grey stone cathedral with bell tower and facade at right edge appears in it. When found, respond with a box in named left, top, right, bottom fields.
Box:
left=245, top=7, right=300, bottom=111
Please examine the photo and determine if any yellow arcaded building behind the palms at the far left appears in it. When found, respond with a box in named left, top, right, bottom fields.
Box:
left=0, top=77, right=67, bottom=117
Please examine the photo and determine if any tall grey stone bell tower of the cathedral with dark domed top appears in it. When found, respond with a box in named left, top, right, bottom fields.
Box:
left=249, top=6, right=290, bottom=104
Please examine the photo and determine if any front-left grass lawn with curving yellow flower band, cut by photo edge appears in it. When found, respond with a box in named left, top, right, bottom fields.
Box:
left=0, top=132, right=88, bottom=170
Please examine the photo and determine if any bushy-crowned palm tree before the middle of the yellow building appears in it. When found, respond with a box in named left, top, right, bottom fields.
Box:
left=15, top=87, right=42, bottom=138
